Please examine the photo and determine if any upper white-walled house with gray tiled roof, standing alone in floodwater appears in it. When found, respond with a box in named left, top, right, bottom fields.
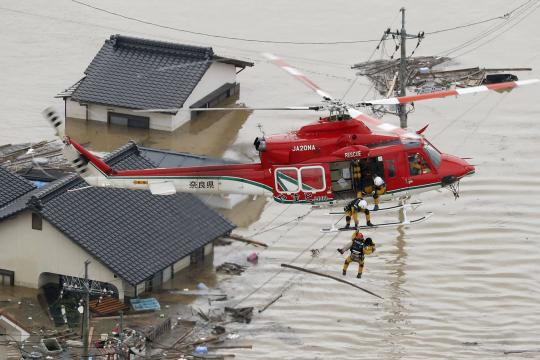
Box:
left=56, top=35, right=253, bottom=131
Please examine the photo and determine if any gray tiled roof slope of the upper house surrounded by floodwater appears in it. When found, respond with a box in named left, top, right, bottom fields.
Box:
left=72, top=35, right=213, bottom=113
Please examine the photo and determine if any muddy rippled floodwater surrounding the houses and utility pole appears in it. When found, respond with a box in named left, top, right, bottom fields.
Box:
left=0, top=0, right=540, bottom=360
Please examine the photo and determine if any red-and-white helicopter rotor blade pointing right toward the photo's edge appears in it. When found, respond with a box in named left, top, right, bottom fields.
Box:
left=358, top=79, right=540, bottom=106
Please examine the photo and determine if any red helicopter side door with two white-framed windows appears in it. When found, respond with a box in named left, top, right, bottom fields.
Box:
left=272, top=164, right=333, bottom=203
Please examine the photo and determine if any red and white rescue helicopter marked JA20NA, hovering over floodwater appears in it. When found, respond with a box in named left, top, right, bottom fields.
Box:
left=43, top=54, right=539, bottom=225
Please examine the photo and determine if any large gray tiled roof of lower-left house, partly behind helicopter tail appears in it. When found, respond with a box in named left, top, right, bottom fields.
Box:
left=7, top=143, right=235, bottom=285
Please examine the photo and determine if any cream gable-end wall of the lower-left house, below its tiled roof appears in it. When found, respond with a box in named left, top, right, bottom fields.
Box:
left=0, top=211, right=124, bottom=299
